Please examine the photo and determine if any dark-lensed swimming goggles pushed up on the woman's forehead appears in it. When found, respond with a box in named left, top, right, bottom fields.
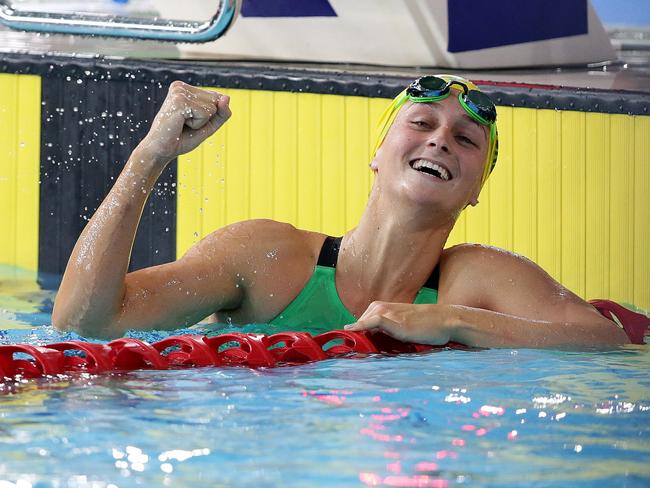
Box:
left=406, top=76, right=497, bottom=126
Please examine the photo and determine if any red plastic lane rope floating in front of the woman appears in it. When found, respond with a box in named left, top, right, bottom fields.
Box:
left=0, top=300, right=650, bottom=382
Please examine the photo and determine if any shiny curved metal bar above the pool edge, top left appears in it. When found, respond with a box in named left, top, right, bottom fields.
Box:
left=0, top=0, right=241, bottom=42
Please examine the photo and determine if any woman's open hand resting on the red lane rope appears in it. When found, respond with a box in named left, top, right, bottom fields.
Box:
left=345, top=302, right=451, bottom=345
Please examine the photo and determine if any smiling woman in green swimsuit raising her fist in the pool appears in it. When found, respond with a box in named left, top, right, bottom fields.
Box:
left=52, top=76, right=629, bottom=347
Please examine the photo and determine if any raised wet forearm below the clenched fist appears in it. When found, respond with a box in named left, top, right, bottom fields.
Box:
left=52, top=148, right=165, bottom=333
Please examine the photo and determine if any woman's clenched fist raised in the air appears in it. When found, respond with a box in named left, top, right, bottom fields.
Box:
left=139, top=81, right=231, bottom=165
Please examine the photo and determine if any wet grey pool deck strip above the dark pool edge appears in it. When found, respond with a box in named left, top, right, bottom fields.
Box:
left=0, top=23, right=650, bottom=93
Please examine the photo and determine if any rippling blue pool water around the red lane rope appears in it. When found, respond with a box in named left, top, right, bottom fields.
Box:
left=0, top=272, right=650, bottom=488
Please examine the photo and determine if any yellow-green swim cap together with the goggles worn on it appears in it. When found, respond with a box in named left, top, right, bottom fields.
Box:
left=372, top=74, right=499, bottom=186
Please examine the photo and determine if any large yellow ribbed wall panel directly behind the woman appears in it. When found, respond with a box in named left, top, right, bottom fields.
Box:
left=177, top=89, right=650, bottom=309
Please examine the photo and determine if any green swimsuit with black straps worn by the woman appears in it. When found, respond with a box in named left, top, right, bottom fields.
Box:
left=269, top=237, right=439, bottom=333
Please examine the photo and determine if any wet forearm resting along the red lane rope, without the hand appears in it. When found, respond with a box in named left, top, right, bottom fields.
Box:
left=438, top=305, right=629, bottom=348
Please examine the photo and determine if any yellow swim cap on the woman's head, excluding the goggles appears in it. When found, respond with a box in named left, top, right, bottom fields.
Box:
left=372, top=74, right=499, bottom=186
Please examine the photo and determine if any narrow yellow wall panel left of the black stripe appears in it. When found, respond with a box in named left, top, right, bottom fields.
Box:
left=0, top=74, right=41, bottom=271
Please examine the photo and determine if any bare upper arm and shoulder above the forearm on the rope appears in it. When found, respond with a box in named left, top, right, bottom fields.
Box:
left=442, top=245, right=607, bottom=323
